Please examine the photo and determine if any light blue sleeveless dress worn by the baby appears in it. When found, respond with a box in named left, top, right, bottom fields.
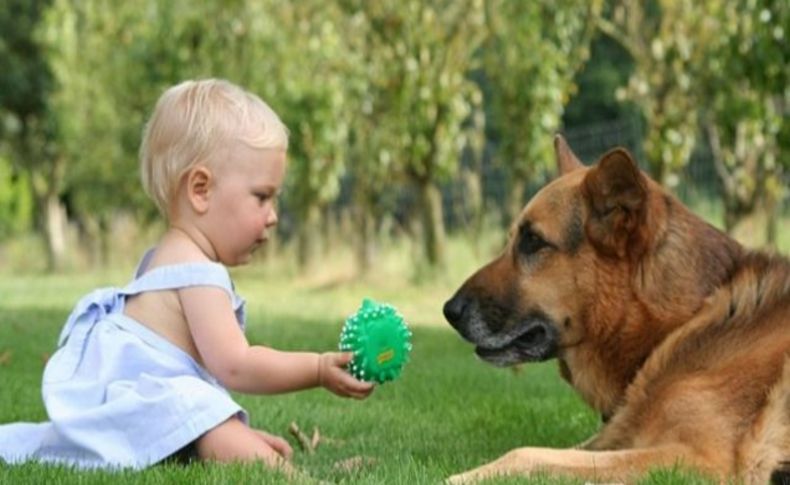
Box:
left=0, top=251, right=247, bottom=468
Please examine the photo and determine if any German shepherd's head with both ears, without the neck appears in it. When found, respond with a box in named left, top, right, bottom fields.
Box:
left=444, top=136, right=676, bottom=366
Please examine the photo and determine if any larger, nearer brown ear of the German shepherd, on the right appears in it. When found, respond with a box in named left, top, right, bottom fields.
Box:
left=582, top=148, right=648, bottom=258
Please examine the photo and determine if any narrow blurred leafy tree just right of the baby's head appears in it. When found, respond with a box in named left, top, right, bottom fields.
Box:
left=266, top=0, right=351, bottom=270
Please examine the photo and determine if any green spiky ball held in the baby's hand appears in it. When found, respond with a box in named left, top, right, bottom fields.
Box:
left=340, top=298, right=411, bottom=384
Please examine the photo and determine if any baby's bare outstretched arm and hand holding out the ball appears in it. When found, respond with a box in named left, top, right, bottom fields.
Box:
left=178, top=286, right=373, bottom=399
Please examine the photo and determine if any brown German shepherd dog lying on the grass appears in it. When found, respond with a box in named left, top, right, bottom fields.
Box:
left=443, top=136, right=790, bottom=484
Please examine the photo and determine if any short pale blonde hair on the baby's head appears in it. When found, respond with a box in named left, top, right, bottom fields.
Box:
left=140, top=79, right=288, bottom=216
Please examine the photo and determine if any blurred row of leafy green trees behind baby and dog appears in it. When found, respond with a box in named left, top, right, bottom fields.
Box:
left=0, top=0, right=790, bottom=278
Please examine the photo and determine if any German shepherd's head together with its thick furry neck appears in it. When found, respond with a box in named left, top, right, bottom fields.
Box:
left=444, top=137, right=741, bottom=414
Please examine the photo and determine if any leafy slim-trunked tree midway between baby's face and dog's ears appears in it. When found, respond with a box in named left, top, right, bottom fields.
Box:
left=341, top=0, right=483, bottom=267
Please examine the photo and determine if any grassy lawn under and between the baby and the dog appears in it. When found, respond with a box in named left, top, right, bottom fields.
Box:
left=0, top=257, right=724, bottom=484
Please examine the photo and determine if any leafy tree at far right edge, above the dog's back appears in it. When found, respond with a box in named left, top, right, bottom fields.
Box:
left=699, top=0, right=790, bottom=244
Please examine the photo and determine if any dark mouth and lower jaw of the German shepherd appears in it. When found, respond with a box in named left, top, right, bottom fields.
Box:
left=475, top=317, right=559, bottom=367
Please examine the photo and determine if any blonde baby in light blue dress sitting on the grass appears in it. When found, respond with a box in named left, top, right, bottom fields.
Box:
left=0, top=79, right=373, bottom=474
